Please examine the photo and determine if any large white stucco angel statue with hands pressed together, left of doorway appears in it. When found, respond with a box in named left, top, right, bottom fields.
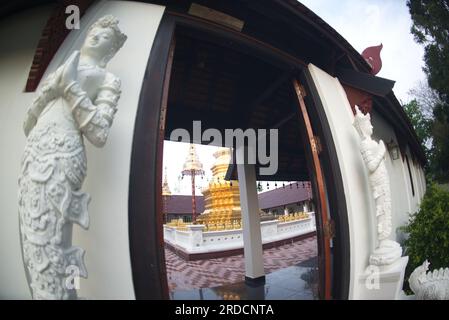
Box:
left=19, top=16, right=126, bottom=299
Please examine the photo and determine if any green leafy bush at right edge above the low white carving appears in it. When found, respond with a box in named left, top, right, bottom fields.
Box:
left=401, top=184, right=449, bottom=286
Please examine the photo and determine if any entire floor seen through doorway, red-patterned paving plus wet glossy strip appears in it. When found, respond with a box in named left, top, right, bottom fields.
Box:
left=166, top=237, right=317, bottom=300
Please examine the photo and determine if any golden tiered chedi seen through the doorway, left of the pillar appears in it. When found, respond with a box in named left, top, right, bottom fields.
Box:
left=197, top=148, right=241, bottom=231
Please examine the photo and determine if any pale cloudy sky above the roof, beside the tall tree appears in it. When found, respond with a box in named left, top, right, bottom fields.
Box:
left=301, top=0, right=426, bottom=103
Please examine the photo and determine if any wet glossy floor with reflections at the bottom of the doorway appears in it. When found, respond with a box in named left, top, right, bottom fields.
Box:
left=170, top=257, right=318, bottom=300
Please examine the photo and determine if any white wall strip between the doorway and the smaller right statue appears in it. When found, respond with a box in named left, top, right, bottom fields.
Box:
left=309, top=64, right=375, bottom=299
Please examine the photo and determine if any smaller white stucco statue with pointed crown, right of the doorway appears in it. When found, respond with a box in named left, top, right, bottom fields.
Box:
left=354, top=106, right=402, bottom=266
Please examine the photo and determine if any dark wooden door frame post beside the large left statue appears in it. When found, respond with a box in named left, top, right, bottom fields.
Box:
left=128, top=16, right=175, bottom=300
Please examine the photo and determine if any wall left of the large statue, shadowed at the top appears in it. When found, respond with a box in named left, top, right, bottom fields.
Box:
left=0, top=6, right=52, bottom=299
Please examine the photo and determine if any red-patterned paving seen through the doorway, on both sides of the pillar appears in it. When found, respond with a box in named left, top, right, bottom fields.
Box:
left=165, top=236, right=318, bottom=291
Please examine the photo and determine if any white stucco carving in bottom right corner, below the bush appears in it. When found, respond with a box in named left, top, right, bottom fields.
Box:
left=408, top=260, right=449, bottom=300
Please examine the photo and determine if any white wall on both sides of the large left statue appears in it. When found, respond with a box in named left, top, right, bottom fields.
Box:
left=0, top=1, right=164, bottom=299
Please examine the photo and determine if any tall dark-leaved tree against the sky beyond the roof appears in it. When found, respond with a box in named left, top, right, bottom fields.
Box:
left=407, top=0, right=449, bottom=182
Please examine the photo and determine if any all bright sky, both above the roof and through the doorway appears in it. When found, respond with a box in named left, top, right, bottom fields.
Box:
left=163, top=0, right=425, bottom=194
